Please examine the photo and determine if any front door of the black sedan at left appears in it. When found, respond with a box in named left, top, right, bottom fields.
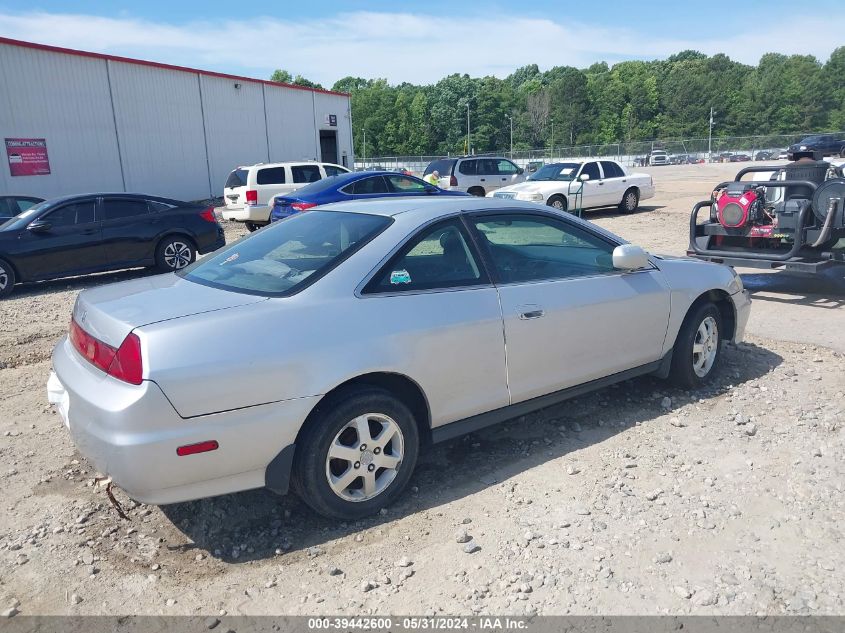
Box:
left=16, top=198, right=106, bottom=279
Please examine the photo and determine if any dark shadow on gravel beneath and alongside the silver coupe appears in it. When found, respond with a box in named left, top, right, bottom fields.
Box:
left=161, top=343, right=783, bottom=563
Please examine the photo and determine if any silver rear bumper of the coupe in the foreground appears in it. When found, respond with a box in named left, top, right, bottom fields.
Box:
left=47, top=338, right=318, bottom=504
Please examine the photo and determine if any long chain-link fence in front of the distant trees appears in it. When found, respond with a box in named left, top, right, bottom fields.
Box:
left=355, top=132, right=845, bottom=175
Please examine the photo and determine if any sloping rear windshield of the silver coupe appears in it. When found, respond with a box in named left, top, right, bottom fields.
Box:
left=182, top=211, right=392, bottom=297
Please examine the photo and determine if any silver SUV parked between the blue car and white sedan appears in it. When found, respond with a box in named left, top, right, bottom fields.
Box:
left=423, top=156, right=525, bottom=196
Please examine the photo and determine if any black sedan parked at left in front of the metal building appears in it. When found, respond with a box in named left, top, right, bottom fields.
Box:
left=0, top=193, right=226, bottom=297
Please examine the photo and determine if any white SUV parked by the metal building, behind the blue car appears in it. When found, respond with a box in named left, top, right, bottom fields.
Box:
left=222, top=161, right=349, bottom=231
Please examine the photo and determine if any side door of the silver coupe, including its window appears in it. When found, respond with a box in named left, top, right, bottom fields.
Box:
left=470, top=212, right=669, bottom=402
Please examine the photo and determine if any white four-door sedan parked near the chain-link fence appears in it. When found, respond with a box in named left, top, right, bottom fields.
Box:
left=487, top=160, right=654, bottom=213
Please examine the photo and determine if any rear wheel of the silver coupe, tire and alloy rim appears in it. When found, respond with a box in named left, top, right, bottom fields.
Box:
left=293, top=387, right=419, bottom=521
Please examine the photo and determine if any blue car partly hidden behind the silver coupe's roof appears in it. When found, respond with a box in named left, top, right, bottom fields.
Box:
left=270, top=171, right=469, bottom=222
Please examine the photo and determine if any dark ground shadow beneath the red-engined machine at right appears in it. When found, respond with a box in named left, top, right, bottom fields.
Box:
left=740, top=266, right=845, bottom=309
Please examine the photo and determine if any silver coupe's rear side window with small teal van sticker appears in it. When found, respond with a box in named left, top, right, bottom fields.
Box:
left=364, top=220, right=487, bottom=293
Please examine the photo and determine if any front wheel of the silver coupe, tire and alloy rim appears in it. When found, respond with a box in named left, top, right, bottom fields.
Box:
left=669, top=301, right=722, bottom=389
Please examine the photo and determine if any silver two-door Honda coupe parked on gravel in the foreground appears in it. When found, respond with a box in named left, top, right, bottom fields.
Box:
left=48, top=198, right=750, bottom=519
